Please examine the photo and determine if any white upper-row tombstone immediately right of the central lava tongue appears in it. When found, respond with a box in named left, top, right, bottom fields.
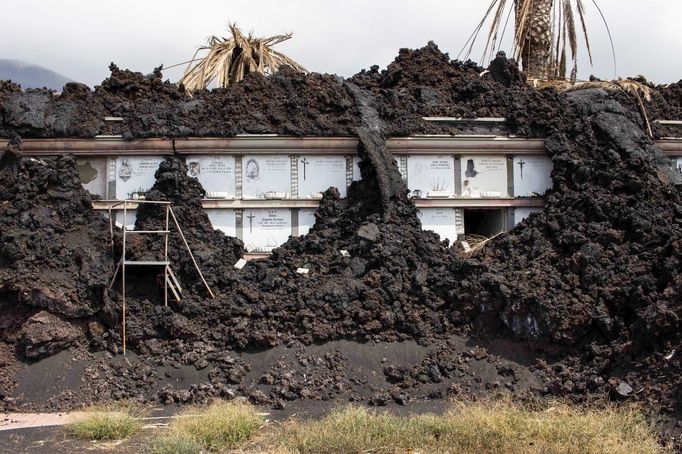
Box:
left=407, top=155, right=455, bottom=198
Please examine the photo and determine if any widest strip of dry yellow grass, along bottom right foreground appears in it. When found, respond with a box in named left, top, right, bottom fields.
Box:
left=266, top=402, right=661, bottom=454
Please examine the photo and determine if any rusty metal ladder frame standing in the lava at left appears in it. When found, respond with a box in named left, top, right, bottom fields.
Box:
left=109, top=200, right=215, bottom=355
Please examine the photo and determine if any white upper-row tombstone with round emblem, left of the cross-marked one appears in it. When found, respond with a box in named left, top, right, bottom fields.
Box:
left=242, top=155, right=291, bottom=199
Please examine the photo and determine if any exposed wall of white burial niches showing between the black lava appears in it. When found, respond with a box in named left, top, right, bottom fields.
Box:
left=18, top=136, right=682, bottom=253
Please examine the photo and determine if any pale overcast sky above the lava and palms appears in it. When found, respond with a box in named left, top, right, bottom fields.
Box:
left=0, top=0, right=682, bottom=86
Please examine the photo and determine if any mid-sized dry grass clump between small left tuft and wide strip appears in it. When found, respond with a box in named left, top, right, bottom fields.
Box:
left=143, top=402, right=265, bottom=454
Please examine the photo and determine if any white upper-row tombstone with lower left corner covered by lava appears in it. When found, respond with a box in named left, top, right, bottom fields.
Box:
left=187, top=155, right=235, bottom=198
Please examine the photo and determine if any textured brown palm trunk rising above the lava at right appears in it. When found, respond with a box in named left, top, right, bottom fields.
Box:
left=515, top=0, right=554, bottom=79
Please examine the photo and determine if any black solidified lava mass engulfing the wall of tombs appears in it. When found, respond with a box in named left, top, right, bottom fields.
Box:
left=0, top=44, right=682, bottom=426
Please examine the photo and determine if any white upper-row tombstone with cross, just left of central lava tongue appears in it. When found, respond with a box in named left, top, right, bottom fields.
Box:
left=298, top=155, right=347, bottom=199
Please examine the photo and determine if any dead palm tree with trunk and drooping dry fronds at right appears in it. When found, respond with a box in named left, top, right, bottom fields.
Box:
left=465, top=0, right=613, bottom=80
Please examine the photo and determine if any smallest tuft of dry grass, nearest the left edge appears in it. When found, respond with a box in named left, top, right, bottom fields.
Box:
left=66, top=405, right=143, bottom=441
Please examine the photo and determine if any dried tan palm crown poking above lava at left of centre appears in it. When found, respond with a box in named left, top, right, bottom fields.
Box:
left=180, top=24, right=306, bottom=92
